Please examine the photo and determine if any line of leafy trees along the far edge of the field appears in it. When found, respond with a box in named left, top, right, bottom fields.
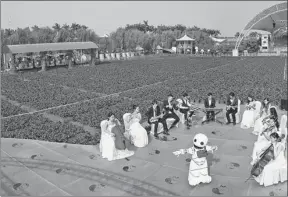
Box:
left=1, top=21, right=259, bottom=53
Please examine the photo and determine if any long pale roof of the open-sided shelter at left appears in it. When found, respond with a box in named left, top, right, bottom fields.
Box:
left=3, top=42, right=98, bottom=54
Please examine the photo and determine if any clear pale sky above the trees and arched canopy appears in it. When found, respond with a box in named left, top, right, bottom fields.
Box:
left=1, top=1, right=284, bottom=36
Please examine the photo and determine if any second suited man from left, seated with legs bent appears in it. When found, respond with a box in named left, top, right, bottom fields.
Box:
left=163, top=94, right=180, bottom=135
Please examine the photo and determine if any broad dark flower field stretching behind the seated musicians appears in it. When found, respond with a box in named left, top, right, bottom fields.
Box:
left=1, top=57, right=287, bottom=144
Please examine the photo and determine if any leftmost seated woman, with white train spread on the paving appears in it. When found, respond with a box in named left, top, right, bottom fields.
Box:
left=100, top=112, right=134, bottom=161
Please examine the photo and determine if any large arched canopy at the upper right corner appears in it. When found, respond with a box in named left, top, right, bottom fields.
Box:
left=235, top=2, right=287, bottom=50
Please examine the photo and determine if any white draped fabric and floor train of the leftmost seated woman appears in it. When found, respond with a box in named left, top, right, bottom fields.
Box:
left=99, top=120, right=134, bottom=161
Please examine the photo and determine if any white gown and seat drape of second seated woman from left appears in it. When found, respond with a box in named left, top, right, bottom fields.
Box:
left=124, top=113, right=148, bottom=148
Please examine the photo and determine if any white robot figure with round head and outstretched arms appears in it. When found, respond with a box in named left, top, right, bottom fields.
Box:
left=173, top=133, right=218, bottom=186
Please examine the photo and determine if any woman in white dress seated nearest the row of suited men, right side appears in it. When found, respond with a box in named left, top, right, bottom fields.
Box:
left=240, top=95, right=256, bottom=129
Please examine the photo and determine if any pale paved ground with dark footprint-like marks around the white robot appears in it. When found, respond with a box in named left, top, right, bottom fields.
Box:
left=1, top=120, right=287, bottom=196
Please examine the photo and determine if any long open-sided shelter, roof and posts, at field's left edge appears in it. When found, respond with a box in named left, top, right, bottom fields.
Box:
left=3, top=42, right=98, bottom=72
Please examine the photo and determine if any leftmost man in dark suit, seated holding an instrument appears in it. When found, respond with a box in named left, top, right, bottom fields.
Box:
left=146, top=100, right=168, bottom=138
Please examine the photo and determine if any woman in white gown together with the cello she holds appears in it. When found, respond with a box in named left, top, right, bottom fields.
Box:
left=252, top=132, right=287, bottom=187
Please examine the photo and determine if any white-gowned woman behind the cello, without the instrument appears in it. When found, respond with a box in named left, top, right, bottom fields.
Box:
left=255, top=132, right=287, bottom=187
